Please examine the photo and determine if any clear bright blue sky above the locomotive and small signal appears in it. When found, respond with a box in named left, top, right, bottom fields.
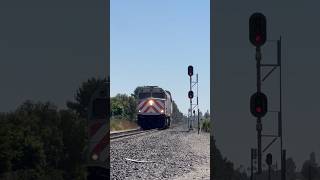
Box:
left=110, top=0, right=210, bottom=114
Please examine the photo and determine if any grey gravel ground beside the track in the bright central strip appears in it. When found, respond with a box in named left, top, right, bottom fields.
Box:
left=110, top=124, right=210, bottom=180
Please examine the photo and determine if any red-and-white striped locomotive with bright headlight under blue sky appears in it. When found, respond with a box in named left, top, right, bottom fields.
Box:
left=137, top=86, right=172, bottom=129
